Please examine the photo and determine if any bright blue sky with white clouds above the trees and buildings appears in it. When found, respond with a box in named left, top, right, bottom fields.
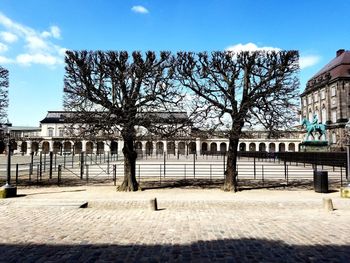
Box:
left=0, top=0, right=350, bottom=126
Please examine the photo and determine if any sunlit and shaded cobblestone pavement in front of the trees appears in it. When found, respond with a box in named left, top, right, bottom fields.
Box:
left=0, top=187, right=350, bottom=262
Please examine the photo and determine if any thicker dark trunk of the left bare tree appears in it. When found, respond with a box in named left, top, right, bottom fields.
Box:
left=118, top=132, right=139, bottom=191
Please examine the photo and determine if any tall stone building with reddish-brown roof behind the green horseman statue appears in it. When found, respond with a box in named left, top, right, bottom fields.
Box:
left=300, top=49, right=350, bottom=150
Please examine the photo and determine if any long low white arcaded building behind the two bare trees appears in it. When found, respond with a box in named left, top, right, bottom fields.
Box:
left=0, top=111, right=303, bottom=156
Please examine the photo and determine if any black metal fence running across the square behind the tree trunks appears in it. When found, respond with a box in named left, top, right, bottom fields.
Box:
left=0, top=152, right=348, bottom=189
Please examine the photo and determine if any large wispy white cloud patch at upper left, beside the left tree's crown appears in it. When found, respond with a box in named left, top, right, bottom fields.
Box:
left=0, top=12, right=66, bottom=66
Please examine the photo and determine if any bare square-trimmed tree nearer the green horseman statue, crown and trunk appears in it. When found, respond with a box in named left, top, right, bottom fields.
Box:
left=176, top=51, right=299, bottom=191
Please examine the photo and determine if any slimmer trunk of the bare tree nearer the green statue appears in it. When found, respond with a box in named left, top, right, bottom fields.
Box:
left=223, top=138, right=239, bottom=192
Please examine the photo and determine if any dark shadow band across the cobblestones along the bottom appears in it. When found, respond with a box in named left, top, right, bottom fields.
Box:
left=0, top=239, right=350, bottom=262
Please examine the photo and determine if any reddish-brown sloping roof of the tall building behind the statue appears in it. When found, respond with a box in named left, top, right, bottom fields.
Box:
left=302, top=49, right=350, bottom=95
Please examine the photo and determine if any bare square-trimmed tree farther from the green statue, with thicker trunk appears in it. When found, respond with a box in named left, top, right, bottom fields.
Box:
left=64, top=51, right=185, bottom=191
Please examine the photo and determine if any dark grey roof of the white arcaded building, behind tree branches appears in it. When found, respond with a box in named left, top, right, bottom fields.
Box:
left=40, top=111, right=188, bottom=123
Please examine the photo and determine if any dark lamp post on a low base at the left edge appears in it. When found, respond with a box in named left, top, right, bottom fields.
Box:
left=0, top=125, right=17, bottom=198
